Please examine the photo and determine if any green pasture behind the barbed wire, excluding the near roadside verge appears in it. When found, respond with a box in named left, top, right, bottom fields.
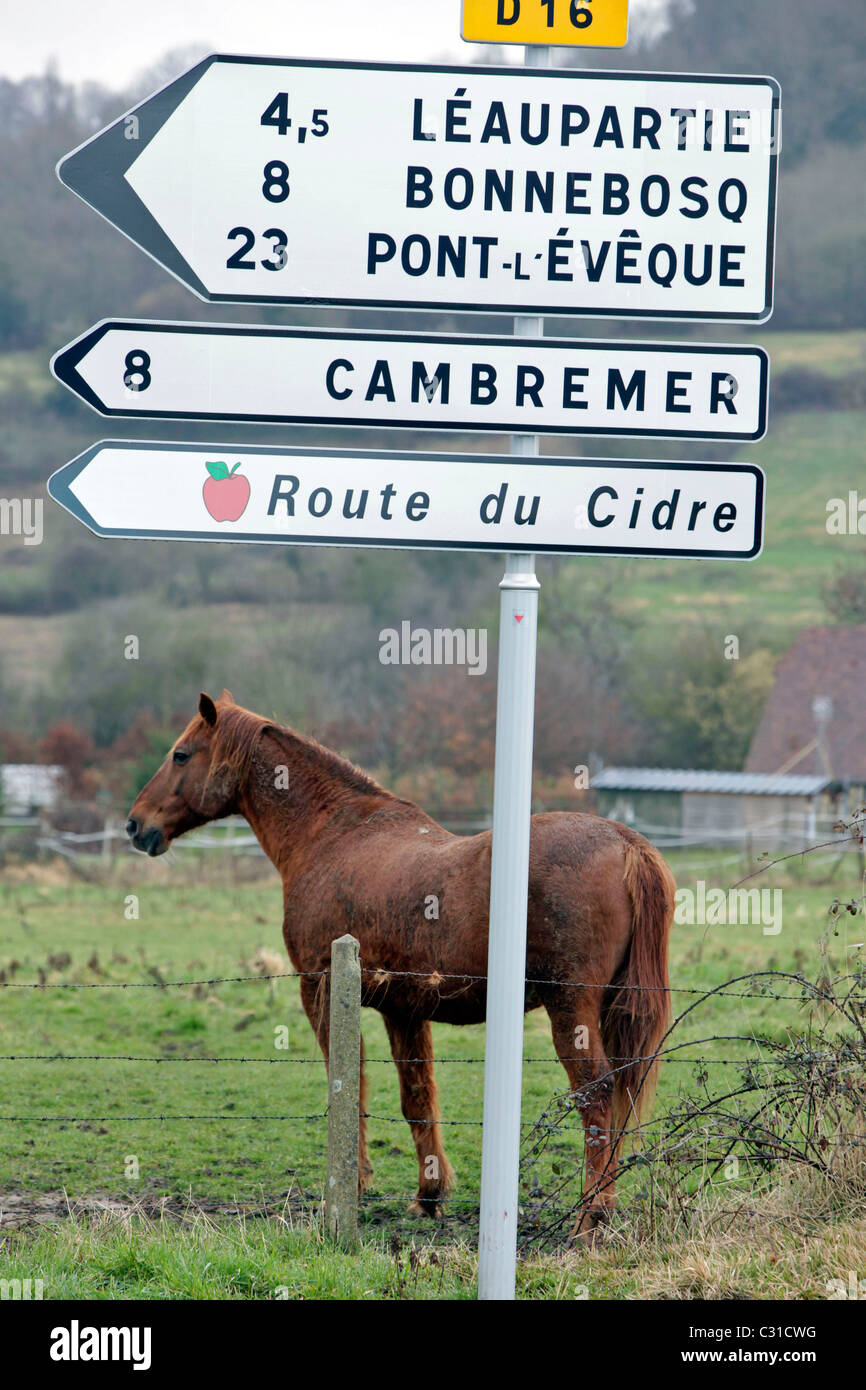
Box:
left=0, top=851, right=863, bottom=1225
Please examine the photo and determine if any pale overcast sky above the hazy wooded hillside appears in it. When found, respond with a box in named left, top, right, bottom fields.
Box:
left=0, top=0, right=666, bottom=88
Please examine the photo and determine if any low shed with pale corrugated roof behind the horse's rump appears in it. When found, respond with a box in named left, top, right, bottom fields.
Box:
left=591, top=767, right=834, bottom=851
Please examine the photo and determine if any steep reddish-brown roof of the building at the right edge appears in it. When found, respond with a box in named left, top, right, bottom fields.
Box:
left=746, top=627, right=866, bottom=813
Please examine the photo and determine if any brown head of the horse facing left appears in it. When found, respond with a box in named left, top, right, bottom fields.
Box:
left=126, top=691, right=238, bottom=856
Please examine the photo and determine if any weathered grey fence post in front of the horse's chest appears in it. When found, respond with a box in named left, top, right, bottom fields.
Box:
left=325, top=935, right=361, bottom=1250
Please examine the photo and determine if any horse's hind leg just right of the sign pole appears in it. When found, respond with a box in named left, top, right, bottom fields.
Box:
left=548, top=990, right=619, bottom=1244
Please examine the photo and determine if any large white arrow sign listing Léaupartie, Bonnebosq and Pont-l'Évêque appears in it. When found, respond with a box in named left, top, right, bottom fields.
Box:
left=58, top=56, right=780, bottom=321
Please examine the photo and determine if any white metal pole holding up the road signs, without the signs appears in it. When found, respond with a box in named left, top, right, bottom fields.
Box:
left=478, top=46, right=550, bottom=1300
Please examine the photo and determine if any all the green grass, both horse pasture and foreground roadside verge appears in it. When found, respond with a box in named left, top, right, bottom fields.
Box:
left=0, top=851, right=866, bottom=1298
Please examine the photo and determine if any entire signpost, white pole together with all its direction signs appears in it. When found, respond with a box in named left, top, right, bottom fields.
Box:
left=49, top=8, right=780, bottom=1298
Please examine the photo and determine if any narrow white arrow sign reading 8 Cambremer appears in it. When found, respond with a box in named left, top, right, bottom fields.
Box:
left=51, top=320, right=769, bottom=439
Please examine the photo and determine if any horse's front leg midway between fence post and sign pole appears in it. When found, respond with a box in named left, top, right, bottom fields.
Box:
left=382, top=1015, right=455, bottom=1216
